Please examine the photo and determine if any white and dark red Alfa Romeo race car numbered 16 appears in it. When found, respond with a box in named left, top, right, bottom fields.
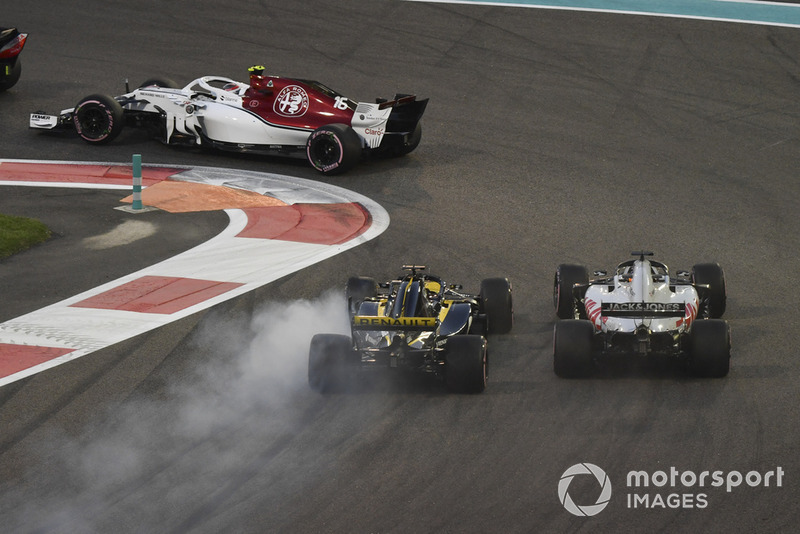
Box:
left=30, top=66, right=428, bottom=174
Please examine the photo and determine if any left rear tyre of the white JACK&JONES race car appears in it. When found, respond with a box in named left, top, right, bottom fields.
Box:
left=553, top=319, right=594, bottom=378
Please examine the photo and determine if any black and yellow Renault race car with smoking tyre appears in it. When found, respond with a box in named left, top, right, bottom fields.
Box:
left=308, top=265, right=514, bottom=393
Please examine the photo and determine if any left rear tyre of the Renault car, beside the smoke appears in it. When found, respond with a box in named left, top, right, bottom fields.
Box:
left=308, top=334, right=358, bottom=393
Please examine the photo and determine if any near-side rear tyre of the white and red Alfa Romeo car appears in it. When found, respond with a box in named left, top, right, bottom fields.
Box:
left=306, top=124, right=362, bottom=175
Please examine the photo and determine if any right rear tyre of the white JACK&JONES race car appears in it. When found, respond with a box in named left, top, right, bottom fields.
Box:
left=689, top=319, right=731, bottom=378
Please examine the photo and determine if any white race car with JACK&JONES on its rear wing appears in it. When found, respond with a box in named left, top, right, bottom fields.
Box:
left=553, top=251, right=730, bottom=377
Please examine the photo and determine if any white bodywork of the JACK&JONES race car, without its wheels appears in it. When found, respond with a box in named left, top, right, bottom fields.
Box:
left=584, top=259, right=699, bottom=333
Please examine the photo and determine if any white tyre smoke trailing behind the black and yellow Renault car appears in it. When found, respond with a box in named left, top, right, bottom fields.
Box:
left=2, top=291, right=349, bottom=532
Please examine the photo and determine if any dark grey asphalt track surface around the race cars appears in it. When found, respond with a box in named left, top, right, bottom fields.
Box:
left=0, top=0, right=800, bottom=532
